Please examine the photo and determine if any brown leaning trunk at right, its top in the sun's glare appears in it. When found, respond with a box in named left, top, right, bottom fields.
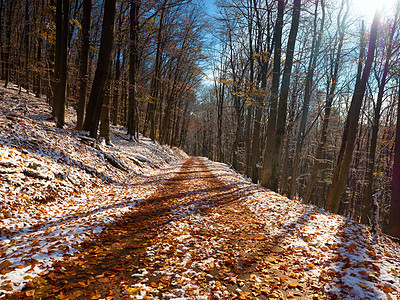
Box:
left=326, top=10, right=380, bottom=213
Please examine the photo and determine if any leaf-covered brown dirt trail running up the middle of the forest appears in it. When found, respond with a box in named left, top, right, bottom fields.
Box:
left=8, top=158, right=325, bottom=299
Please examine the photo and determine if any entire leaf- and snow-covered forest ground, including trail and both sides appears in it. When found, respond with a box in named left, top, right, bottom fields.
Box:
left=0, top=82, right=400, bottom=299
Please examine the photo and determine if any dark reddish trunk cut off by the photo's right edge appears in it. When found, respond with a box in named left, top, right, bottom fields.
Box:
left=388, top=78, right=400, bottom=239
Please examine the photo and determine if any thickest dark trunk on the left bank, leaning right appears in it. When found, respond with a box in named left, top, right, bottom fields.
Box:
left=83, top=0, right=116, bottom=138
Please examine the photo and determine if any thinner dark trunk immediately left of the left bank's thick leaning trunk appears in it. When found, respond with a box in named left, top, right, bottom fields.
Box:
left=76, top=0, right=92, bottom=130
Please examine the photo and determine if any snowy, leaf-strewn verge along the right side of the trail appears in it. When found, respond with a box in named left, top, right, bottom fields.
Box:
left=211, top=162, right=400, bottom=299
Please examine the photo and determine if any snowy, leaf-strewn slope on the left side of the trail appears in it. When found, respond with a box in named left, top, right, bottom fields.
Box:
left=0, top=83, right=187, bottom=296
